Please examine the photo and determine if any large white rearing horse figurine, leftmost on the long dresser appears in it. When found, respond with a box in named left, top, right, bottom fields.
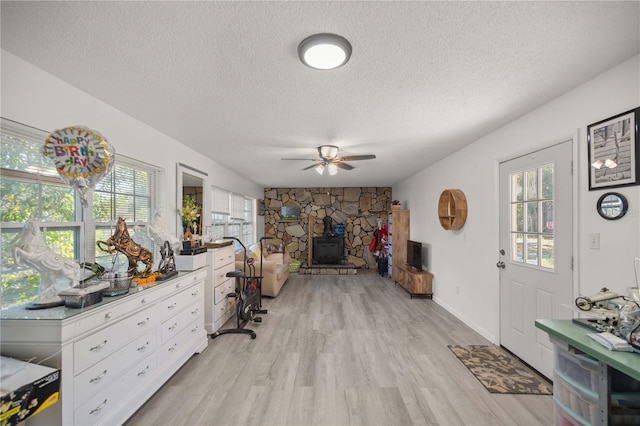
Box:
left=11, top=218, right=80, bottom=309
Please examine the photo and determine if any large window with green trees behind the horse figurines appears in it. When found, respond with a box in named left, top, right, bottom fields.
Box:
left=0, top=119, right=161, bottom=309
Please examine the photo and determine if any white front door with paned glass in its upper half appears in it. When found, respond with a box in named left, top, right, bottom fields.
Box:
left=497, top=141, right=573, bottom=378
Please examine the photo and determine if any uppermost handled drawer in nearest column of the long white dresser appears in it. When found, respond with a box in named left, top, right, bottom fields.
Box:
left=73, top=306, right=159, bottom=375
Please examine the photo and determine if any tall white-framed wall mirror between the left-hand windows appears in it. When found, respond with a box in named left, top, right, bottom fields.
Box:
left=176, top=163, right=210, bottom=239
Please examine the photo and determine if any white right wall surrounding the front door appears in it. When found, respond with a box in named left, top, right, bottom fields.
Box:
left=393, top=55, right=640, bottom=343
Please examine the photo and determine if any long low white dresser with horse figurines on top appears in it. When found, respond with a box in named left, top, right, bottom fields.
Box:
left=0, top=268, right=208, bottom=426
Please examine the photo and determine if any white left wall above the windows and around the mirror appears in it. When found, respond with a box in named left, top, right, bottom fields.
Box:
left=0, top=50, right=264, bottom=240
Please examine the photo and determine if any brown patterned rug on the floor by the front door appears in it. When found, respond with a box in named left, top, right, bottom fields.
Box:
left=448, top=345, right=553, bottom=395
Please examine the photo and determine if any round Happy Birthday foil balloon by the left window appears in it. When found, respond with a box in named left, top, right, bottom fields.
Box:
left=42, top=126, right=115, bottom=207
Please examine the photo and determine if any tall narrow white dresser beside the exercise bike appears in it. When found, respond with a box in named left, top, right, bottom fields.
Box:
left=204, top=245, right=236, bottom=334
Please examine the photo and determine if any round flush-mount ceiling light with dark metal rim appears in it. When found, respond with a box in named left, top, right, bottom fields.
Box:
left=298, top=33, right=351, bottom=70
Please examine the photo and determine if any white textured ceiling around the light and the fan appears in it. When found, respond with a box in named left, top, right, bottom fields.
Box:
left=1, top=1, right=640, bottom=187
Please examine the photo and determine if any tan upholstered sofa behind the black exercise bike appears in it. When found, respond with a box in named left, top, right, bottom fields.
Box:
left=236, top=244, right=291, bottom=297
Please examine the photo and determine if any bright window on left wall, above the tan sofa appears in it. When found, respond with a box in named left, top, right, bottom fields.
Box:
left=209, top=187, right=256, bottom=245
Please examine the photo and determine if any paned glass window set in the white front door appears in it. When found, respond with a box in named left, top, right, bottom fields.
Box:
left=510, top=164, right=555, bottom=269
